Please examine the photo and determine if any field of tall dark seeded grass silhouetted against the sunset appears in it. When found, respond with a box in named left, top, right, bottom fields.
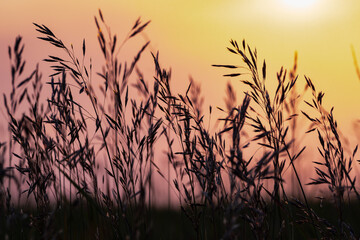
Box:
left=0, top=8, right=360, bottom=239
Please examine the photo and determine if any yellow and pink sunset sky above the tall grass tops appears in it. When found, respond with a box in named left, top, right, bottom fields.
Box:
left=0, top=0, right=360, bottom=136
